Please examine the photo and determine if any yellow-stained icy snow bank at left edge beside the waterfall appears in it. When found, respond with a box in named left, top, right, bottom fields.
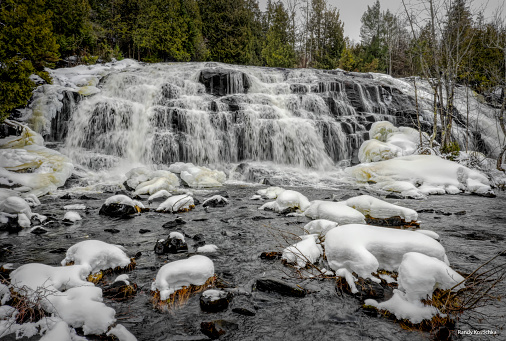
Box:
left=0, top=120, right=74, bottom=196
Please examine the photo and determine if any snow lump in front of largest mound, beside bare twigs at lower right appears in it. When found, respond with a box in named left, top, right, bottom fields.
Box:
left=365, top=252, right=464, bottom=324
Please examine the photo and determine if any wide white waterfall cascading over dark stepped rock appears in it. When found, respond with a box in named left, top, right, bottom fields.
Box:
left=23, top=60, right=502, bottom=181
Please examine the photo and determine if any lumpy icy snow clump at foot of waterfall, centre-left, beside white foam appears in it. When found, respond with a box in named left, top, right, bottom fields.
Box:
left=169, top=162, right=227, bottom=188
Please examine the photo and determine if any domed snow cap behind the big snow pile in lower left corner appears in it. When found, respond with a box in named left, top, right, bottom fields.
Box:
left=61, top=240, right=131, bottom=273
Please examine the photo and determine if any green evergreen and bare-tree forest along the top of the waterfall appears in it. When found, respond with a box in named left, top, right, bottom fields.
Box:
left=0, top=0, right=506, bottom=126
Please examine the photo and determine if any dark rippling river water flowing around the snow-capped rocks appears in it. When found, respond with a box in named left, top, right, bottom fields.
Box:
left=0, top=185, right=506, bottom=341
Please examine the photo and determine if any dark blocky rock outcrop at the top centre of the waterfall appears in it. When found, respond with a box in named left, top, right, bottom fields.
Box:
left=199, top=67, right=251, bottom=96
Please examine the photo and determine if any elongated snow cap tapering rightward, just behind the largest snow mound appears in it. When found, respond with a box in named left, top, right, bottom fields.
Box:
left=344, top=195, right=418, bottom=222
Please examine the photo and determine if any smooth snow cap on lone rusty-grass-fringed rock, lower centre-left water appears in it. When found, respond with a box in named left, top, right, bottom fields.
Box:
left=151, top=255, right=214, bottom=301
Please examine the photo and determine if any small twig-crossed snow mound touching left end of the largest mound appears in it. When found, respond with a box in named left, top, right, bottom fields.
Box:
left=281, top=234, right=323, bottom=268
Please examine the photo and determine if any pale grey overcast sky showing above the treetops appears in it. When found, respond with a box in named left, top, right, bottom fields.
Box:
left=259, top=0, right=506, bottom=42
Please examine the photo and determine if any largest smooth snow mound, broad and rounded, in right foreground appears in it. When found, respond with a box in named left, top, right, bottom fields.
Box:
left=324, top=224, right=448, bottom=292
